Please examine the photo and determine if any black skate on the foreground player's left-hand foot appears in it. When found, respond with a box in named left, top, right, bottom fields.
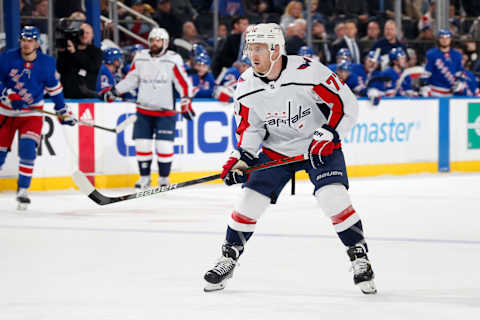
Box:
left=203, top=243, right=240, bottom=292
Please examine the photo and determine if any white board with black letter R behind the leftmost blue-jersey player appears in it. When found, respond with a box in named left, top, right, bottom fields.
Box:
left=0, top=103, right=78, bottom=177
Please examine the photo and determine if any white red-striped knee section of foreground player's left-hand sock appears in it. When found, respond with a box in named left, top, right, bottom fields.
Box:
left=228, top=188, right=270, bottom=232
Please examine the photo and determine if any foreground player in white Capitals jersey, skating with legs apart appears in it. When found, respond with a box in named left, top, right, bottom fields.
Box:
left=204, top=23, right=377, bottom=294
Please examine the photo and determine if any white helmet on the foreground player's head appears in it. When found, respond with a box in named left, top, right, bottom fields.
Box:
left=244, top=23, right=285, bottom=77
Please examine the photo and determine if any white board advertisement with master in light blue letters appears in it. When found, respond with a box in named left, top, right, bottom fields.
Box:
left=342, top=99, right=438, bottom=165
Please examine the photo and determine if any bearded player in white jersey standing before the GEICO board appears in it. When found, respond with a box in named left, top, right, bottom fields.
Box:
left=101, top=28, right=195, bottom=189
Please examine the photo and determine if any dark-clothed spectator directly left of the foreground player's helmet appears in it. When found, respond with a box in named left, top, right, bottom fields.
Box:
left=212, top=16, right=248, bottom=77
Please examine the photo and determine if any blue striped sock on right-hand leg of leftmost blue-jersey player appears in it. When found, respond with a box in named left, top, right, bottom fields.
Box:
left=18, top=138, right=37, bottom=189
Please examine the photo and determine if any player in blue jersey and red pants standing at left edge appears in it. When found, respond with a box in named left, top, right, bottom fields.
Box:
left=0, top=26, right=76, bottom=210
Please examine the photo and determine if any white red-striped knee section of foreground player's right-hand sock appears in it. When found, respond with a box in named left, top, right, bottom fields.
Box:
left=315, top=184, right=360, bottom=232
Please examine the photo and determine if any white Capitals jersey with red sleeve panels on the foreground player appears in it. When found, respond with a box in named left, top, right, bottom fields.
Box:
left=234, top=56, right=358, bottom=156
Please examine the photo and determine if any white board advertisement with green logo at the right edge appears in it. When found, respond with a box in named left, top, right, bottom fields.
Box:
left=450, top=99, right=480, bottom=161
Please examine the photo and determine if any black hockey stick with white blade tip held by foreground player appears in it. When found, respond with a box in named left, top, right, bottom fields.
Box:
left=72, top=154, right=308, bottom=206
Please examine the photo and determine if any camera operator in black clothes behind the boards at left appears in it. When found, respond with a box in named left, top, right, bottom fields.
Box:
left=57, top=23, right=103, bottom=99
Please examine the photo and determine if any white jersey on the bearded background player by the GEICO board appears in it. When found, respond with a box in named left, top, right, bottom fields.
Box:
left=115, top=49, right=192, bottom=115
